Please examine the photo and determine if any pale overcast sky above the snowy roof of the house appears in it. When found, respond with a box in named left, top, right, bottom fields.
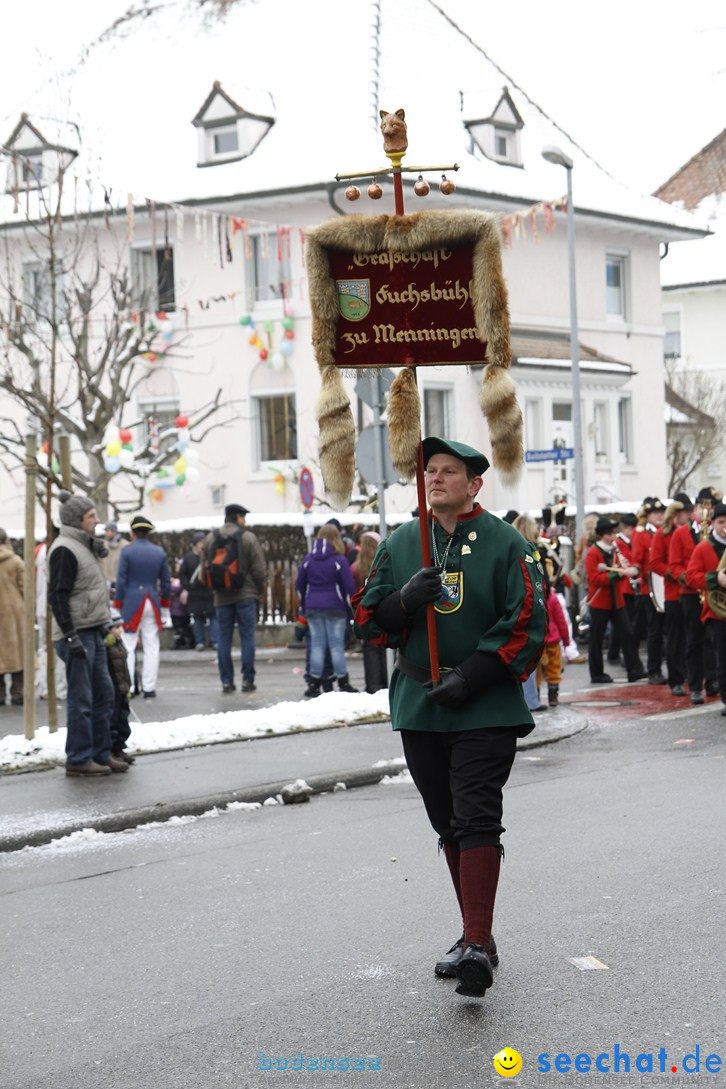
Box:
left=0, top=0, right=726, bottom=193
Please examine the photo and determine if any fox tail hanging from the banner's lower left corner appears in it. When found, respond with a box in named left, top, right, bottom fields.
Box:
left=316, top=366, right=356, bottom=511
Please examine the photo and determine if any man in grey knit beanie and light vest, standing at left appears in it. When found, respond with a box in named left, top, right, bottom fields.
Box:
left=48, top=491, right=128, bottom=778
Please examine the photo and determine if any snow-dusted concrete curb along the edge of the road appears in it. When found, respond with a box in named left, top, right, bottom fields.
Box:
left=0, top=711, right=588, bottom=853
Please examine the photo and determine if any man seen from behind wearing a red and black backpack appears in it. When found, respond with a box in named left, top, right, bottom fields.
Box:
left=202, top=503, right=267, bottom=695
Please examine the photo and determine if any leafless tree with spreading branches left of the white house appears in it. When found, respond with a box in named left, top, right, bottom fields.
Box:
left=0, top=149, right=232, bottom=517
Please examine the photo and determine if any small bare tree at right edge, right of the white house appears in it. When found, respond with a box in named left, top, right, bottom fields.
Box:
left=665, top=363, right=726, bottom=495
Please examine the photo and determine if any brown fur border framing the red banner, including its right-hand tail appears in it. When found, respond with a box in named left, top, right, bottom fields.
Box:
left=305, top=209, right=524, bottom=490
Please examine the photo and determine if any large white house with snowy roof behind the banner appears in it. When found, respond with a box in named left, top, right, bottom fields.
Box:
left=0, top=4, right=703, bottom=522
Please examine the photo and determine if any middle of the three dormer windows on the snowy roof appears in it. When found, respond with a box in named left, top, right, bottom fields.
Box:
left=192, top=81, right=275, bottom=167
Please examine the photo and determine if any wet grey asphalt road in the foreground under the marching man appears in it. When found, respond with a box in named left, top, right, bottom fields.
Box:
left=0, top=707, right=726, bottom=1089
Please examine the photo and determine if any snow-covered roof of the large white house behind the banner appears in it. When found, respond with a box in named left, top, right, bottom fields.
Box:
left=0, top=0, right=702, bottom=237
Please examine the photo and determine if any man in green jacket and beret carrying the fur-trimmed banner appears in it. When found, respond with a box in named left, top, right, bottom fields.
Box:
left=354, top=438, right=546, bottom=998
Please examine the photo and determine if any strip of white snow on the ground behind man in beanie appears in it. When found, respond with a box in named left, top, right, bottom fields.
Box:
left=0, top=688, right=389, bottom=771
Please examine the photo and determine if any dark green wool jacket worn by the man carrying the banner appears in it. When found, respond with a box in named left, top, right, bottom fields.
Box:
left=354, top=504, right=546, bottom=736
